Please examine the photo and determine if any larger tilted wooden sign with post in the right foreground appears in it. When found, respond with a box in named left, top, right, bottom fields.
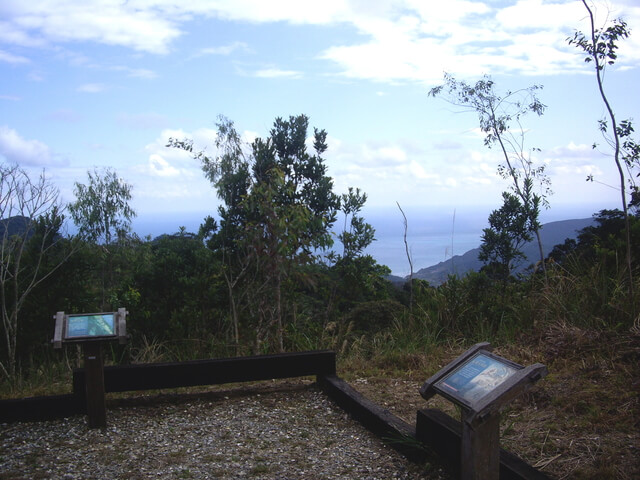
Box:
left=420, top=342, right=547, bottom=480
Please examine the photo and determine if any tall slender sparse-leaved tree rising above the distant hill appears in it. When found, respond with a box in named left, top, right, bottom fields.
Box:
left=429, top=74, right=551, bottom=278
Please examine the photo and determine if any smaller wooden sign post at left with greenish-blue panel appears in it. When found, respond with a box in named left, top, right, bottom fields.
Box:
left=52, top=308, right=127, bottom=428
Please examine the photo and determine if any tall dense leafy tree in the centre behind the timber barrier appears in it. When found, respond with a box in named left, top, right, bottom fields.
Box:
left=168, top=115, right=339, bottom=350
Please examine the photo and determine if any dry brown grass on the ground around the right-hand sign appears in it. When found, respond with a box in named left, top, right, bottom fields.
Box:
left=344, top=324, right=640, bottom=480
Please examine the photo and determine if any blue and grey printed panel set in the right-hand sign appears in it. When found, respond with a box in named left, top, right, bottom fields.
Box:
left=435, top=352, right=519, bottom=403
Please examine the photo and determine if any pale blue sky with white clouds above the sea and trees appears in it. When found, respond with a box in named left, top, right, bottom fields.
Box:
left=0, top=0, right=640, bottom=240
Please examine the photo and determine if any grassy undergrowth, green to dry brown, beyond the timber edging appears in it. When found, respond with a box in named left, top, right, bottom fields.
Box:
left=0, top=256, right=640, bottom=479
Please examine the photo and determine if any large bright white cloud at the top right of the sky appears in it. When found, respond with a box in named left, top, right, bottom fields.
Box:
left=321, top=0, right=640, bottom=83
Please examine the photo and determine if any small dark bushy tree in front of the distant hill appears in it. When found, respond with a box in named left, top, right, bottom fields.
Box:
left=478, top=192, right=537, bottom=281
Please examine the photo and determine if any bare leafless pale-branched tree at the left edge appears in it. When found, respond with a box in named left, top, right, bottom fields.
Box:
left=0, top=165, right=74, bottom=378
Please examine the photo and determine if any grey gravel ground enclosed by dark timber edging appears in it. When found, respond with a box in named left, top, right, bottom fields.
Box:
left=0, top=386, right=439, bottom=480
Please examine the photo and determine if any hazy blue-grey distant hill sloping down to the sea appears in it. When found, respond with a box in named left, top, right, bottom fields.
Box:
left=404, top=218, right=594, bottom=285
